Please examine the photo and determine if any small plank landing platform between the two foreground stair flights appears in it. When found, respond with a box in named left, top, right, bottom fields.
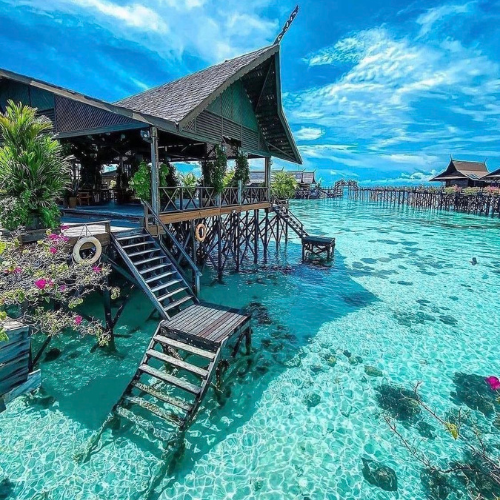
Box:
left=162, top=304, right=250, bottom=345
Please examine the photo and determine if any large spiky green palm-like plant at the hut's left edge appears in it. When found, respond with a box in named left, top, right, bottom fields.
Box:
left=0, top=101, right=70, bottom=230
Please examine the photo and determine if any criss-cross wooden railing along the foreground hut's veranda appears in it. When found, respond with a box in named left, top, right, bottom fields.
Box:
left=159, top=186, right=271, bottom=212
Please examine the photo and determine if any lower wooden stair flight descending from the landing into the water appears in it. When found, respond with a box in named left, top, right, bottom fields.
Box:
left=113, top=323, right=222, bottom=431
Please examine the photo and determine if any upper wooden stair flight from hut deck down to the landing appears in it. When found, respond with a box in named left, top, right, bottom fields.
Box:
left=111, top=229, right=198, bottom=320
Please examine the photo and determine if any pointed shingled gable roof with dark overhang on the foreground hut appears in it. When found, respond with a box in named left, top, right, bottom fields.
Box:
left=115, top=44, right=302, bottom=163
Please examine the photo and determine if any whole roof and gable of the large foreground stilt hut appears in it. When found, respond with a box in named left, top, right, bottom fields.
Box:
left=0, top=44, right=302, bottom=163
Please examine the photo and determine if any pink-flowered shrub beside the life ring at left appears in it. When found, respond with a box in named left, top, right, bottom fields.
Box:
left=0, top=231, right=119, bottom=345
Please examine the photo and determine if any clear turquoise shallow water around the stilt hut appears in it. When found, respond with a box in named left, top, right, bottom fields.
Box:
left=0, top=200, right=500, bottom=500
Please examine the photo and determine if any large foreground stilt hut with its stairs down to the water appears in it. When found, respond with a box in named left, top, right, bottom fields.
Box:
left=0, top=29, right=334, bottom=454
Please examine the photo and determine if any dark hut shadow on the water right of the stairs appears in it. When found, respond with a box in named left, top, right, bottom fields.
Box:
left=152, top=244, right=378, bottom=498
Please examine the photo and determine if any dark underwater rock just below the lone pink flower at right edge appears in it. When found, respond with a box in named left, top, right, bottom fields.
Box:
left=451, top=372, right=500, bottom=417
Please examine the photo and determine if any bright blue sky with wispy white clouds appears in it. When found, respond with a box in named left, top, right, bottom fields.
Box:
left=0, top=0, right=500, bottom=184
